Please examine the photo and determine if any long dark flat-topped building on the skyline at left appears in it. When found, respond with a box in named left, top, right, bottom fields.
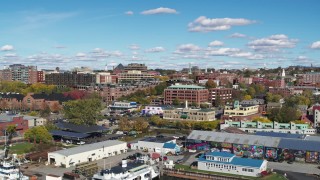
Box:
left=45, top=72, right=96, bottom=87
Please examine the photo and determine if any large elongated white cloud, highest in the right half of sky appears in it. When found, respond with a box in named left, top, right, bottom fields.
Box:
left=188, top=16, right=255, bottom=32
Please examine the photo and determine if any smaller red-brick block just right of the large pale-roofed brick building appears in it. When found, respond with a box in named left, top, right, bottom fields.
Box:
left=209, top=88, right=233, bottom=105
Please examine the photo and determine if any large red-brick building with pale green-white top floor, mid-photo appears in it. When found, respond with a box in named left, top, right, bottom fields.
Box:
left=164, top=85, right=209, bottom=105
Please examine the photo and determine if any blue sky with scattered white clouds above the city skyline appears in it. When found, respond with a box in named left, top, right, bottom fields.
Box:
left=0, top=0, right=320, bottom=69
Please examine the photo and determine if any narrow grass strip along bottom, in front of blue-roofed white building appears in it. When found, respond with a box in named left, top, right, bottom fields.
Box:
left=175, top=164, right=286, bottom=180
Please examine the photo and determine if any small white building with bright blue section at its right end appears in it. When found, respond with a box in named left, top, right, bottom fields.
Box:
left=131, top=137, right=180, bottom=154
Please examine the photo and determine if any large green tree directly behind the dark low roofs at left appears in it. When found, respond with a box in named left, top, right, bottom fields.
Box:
left=63, top=98, right=103, bottom=125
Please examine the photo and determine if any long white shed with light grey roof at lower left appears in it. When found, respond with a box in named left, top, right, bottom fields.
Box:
left=48, top=140, right=127, bottom=168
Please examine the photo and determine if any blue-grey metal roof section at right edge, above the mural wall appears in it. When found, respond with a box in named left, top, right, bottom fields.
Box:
left=278, top=138, right=320, bottom=152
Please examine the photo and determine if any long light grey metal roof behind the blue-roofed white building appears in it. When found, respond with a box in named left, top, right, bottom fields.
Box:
left=188, top=130, right=281, bottom=147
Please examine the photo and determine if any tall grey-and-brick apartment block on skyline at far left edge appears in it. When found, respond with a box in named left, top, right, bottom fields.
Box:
left=0, top=64, right=38, bottom=84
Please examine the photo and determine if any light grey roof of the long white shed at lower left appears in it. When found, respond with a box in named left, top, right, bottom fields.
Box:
left=49, top=140, right=126, bottom=156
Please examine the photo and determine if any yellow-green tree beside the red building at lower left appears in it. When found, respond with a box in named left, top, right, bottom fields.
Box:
left=24, top=126, right=53, bottom=144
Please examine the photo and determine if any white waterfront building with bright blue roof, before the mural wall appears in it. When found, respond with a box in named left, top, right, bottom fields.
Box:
left=198, top=152, right=267, bottom=177
